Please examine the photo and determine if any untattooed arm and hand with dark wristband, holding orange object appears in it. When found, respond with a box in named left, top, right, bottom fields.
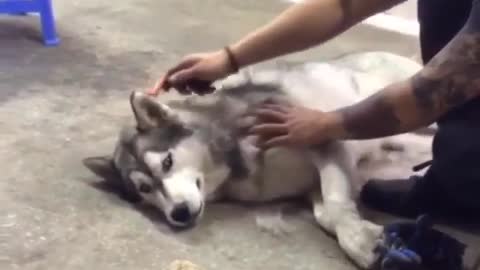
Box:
left=156, top=0, right=405, bottom=95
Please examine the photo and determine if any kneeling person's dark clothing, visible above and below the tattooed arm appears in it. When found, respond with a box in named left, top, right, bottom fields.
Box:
left=361, top=0, right=480, bottom=219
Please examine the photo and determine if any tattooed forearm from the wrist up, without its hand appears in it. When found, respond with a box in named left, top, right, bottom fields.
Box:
left=332, top=1, right=480, bottom=139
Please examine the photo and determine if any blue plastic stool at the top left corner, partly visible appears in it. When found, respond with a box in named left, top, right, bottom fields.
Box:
left=0, top=0, right=60, bottom=46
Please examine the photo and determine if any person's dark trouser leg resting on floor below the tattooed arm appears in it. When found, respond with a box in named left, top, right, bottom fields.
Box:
left=361, top=118, right=480, bottom=221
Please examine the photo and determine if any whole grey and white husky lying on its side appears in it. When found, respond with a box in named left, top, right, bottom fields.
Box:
left=84, top=53, right=424, bottom=268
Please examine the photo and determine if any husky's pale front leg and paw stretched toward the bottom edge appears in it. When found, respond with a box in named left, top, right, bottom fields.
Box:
left=313, top=143, right=383, bottom=269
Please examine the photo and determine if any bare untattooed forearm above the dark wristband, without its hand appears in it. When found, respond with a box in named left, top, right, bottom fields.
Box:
left=230, top=0, right=405, bottom=67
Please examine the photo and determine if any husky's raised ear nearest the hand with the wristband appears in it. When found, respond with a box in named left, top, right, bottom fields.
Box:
left=130, top=91, right=178, bottom=131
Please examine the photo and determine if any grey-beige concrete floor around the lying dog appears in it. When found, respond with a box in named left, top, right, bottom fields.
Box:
left=0, top=0, right=478, bottom=270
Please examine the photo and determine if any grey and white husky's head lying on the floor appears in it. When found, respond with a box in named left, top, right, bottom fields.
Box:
left=84, top=92, right=223, bottom=227
